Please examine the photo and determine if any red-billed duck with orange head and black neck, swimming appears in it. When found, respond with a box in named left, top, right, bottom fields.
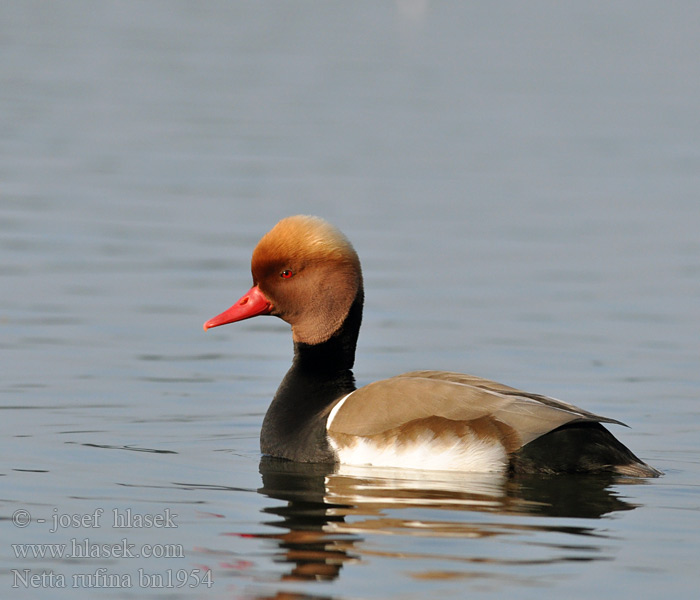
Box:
left=204, top=215, right=661, bottom=477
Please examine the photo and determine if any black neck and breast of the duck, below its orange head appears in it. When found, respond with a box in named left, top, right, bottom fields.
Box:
left=260, top=289, right=364, bottom=462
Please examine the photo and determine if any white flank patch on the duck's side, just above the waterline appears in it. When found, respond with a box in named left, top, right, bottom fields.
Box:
left=328, top=428, right=508, bottom=473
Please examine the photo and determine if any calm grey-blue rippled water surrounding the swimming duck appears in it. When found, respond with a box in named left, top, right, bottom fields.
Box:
left=0, top=0, right=700, bottom=600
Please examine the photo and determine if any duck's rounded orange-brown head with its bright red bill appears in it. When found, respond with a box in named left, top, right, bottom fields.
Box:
left=204, top=215, right=362, bottom=344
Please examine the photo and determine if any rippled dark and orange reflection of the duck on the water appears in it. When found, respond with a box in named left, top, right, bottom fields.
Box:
left=256, top=457, right=639, bottom=581
